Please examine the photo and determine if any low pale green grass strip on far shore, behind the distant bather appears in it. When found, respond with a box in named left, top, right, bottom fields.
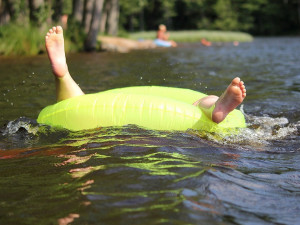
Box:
left=129, top=30, right=253, bottom=42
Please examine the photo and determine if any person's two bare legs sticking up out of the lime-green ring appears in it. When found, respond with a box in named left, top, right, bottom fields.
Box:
left=45, top=26, right=246, bottom=123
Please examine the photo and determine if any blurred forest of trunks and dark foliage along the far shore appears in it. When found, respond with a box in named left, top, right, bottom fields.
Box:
left=0, top=0, right=300, bottom=55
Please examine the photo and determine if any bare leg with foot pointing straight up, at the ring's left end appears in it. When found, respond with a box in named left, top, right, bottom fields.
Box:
left=45, top=26, right=84, bottom=101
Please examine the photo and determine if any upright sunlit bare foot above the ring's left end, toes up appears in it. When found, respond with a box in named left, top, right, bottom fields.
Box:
left=45, top=26, right=68, bottom=78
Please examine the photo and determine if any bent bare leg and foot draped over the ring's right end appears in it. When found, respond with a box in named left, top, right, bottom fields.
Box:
left=193, top=77, right=246, bottom=123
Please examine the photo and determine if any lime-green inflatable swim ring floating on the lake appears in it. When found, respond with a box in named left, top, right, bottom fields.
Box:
left=37, top=86, right=246, bottom=133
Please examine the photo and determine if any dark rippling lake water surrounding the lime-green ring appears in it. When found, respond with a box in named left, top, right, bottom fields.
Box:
left=0, top=38, right=300, bottom=224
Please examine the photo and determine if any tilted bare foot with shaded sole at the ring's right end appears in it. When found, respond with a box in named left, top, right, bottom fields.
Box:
left=212, top=77, right=246, bottom=123
